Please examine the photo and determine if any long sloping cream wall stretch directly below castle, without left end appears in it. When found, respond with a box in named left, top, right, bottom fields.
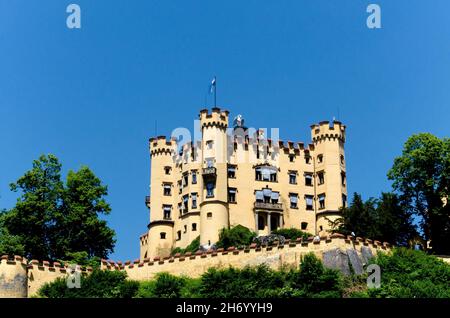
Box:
left=102, top=234, right=390, bottom=280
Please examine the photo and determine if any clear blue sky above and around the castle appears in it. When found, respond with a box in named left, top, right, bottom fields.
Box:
left=0, top=0, right=450, bottom=260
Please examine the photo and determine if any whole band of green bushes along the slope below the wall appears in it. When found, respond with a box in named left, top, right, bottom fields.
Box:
left=39, top=248, right=450, bottom=298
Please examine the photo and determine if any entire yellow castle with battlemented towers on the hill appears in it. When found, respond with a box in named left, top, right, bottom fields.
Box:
left=140, top=107, right=347, bottom=259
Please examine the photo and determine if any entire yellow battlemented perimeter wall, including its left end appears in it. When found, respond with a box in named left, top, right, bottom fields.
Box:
left=0, top=234, right=390, bottom=298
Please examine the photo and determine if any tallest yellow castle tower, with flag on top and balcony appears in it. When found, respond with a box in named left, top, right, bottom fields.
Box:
left=200, top=107, right=230, bottom=246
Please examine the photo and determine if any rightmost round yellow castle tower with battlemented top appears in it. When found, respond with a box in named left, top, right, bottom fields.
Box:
left=311, top=121, right=347, bottom=235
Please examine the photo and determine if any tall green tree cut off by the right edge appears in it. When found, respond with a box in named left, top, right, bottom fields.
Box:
left=388, top=133, right=450, bottom=254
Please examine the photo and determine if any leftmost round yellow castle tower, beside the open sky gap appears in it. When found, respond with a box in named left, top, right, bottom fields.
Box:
left=146, top=136, right=177, bottom=258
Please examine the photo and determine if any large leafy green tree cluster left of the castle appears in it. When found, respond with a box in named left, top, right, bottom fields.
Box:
left=0, top=155, right=115, bottom=264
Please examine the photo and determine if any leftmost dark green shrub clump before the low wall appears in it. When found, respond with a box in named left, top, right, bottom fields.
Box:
left=38, top=269, right=139, bottom=298
